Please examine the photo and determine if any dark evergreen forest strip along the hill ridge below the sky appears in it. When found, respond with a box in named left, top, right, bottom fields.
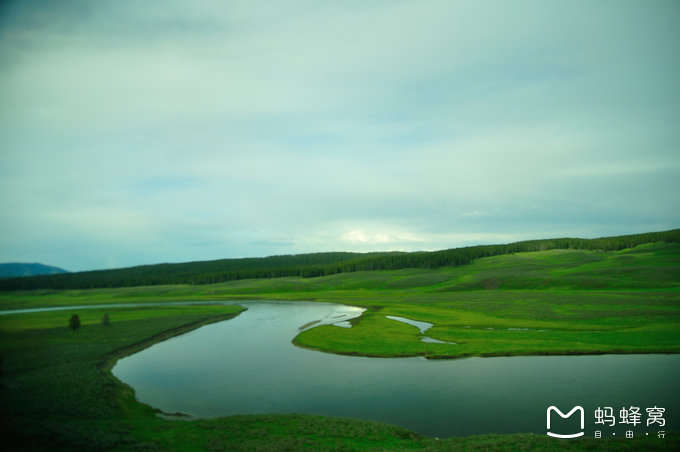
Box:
left=0, top=229, right=680, bottom=291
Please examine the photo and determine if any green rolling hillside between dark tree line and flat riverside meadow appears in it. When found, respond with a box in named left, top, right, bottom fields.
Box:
left=5, top=242, right=680, bottom=309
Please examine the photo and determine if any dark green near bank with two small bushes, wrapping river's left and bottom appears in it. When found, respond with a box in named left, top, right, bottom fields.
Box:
left=0, top=306, right=680, bottom=451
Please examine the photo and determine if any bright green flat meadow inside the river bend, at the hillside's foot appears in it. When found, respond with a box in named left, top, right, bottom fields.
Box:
left=296, top=290, right=680, bottom=357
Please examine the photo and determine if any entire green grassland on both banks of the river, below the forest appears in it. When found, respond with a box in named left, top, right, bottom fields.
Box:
left=0, top=243, right=680, bottom=450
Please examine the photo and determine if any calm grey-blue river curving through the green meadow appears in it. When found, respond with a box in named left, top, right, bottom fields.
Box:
left=113, top=302, right=680, bottom=437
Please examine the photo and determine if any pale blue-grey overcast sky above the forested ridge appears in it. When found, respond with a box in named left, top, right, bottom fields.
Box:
left=0, top=0, right=680, bottom=271
